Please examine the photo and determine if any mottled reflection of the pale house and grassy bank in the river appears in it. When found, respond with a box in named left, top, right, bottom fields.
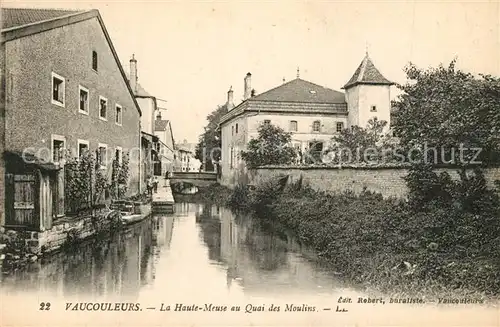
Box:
left=196, top=206, right=338, bottom=295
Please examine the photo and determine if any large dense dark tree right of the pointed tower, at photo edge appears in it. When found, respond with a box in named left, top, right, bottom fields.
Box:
left=394, top=60, right=500, bottom=163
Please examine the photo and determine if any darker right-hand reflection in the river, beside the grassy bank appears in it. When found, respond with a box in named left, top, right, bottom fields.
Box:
left=215, top=208, right=340, bottom=293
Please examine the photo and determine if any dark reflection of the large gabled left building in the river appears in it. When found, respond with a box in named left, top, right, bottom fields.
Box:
left=2, top=219, right=158, bottom=300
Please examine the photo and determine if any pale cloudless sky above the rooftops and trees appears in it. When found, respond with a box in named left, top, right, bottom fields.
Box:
left=0, top=0, right=500, bottom=142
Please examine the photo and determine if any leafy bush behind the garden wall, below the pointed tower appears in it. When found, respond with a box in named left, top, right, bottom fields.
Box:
left=329, top=118, right=396, bottom=163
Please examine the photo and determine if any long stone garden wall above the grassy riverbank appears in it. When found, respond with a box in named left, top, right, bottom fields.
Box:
left=248, top=166, right=500, bottom=198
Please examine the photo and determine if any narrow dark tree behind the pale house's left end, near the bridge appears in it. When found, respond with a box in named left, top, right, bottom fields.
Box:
left=195, top=105, right=227, bottom=171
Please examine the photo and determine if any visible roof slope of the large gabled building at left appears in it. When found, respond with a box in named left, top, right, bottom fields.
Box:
left=2, top=8, right=82, bottom=29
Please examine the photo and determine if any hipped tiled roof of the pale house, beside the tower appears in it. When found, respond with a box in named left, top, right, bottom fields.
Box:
left=249, top=78, right=345, bottom=103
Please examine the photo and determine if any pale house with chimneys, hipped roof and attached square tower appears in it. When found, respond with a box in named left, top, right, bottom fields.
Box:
left=220, top=54, right=393, bottom=185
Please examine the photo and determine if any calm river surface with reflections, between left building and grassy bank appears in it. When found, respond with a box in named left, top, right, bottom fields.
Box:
left=1, top=203, right=336, bottom=301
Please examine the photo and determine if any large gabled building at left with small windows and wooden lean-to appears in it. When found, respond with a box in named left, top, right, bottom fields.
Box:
left=0, top=8, right=145, bottom=230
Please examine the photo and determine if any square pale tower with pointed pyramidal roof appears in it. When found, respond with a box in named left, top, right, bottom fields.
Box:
left=343, top=51, right=394, bottom=129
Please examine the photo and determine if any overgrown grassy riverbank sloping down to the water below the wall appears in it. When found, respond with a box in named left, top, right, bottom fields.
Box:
left=193, top=179, right=500, bottom=299
